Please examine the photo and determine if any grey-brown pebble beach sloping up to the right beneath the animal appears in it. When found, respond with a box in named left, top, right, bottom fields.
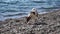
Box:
left=0, top=10, right=60, bottom=34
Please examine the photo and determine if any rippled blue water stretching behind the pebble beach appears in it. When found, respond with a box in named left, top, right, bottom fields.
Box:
left=0, top=0, right=60, bottom=20
